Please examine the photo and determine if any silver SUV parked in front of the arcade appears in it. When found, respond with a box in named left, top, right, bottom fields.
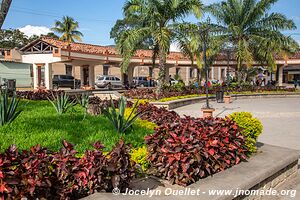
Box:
left=95, top=75, right=123, bottom=89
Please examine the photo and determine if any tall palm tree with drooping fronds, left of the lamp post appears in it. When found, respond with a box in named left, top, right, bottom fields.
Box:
left=117, top=0, right=202, bottom=89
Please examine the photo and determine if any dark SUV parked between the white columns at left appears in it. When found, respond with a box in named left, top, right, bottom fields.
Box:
left=52, top=75, right=80, bottom=89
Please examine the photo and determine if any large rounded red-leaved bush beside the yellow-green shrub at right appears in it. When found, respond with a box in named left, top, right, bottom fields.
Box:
left=145, top=117, right=247, bottom=186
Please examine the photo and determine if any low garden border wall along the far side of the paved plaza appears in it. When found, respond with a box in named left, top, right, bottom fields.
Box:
left=150, top=92, right=300, bottom=110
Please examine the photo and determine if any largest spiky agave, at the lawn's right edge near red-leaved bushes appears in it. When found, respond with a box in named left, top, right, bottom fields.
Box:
left=104, top=96, right=141, bottom=134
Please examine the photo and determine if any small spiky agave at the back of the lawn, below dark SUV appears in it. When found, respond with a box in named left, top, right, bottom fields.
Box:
left=48, top=93, right=75, bottom=115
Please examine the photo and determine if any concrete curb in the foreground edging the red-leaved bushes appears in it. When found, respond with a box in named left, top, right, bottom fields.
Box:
left=84, top=144, right=300, bottom=200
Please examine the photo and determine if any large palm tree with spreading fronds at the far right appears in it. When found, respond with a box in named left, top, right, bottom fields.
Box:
left=208, top=0, right=298, bottom=82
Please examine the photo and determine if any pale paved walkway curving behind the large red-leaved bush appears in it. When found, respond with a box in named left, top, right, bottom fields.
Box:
left=175, top=97, right=300, bottom=150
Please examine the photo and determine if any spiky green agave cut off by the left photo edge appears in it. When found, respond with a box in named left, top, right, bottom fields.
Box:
left=0, top=89, right=22, bottom=126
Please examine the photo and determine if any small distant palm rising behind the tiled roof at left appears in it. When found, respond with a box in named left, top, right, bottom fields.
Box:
left=52, top=16, right=83, bottom=43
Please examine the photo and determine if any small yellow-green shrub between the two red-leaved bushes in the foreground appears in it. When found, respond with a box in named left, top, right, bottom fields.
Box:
left=130, top=146, right=150, bottom=171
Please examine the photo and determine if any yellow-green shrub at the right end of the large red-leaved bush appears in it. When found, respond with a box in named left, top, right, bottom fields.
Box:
left=230, top=112, right=263, bottom=154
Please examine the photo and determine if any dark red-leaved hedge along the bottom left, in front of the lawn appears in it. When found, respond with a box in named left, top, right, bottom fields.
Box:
left=0, top=141, right=134, bottom=200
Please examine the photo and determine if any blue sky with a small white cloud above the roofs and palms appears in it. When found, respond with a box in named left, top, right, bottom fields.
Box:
left=3, top=0, right=300, bottom=45
